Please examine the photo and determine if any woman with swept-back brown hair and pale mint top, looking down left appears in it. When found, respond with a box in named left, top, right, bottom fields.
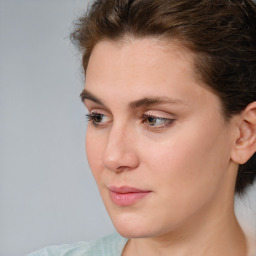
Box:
left=30, top=0, right=256, bottom=256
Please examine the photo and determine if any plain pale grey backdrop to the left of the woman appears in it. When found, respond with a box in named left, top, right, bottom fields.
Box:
left=0, top=0, right=114, bottom=256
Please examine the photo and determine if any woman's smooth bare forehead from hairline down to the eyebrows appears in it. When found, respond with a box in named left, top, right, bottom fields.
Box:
left=86, top=38, right=220, bottom=111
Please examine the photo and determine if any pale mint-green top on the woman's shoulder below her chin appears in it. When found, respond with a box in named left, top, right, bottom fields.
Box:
left=27, top=234, right=127, bottom=256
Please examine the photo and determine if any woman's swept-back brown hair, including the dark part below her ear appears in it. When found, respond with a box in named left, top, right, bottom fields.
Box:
left=71, top=0, right=256, bottom=192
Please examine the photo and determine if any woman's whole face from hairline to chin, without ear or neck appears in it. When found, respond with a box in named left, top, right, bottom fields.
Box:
left=82, top=38, right=238, bottom=237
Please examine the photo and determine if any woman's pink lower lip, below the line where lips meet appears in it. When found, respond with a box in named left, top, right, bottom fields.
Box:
left=110, top=191, right=150, bottom=206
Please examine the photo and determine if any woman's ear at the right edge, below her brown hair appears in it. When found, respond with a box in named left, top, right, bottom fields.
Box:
left=231, top=102, right=256, bottom=164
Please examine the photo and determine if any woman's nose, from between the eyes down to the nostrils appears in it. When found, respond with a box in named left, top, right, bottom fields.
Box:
left=103, top=125, right=139, bottom=172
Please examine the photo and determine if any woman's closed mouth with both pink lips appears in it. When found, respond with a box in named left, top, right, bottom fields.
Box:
left=109, top=186, right=152, bottom=206
